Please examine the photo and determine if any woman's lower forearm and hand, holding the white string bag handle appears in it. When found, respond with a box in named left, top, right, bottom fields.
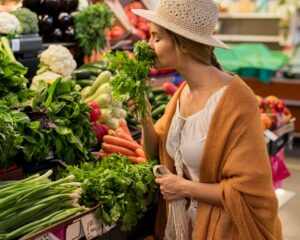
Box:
left=155, top=174, right=222, bottom=206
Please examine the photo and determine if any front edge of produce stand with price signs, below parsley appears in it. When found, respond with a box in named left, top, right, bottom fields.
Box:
left=22, top=206, right=156, bottom=240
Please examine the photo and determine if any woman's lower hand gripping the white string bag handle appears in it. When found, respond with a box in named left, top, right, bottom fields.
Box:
left=155, top=173, right=186, bottom=201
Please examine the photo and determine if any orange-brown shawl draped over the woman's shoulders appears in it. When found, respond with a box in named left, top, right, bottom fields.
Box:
left=155, top=76, right=282, bottom=240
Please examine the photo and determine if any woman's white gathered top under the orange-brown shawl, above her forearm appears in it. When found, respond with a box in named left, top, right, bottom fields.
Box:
left=166, top=86, right=227, bottom=181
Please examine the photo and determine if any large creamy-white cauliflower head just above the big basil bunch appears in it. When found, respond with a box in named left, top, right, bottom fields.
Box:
left=40, top=44, right=76, bottom=77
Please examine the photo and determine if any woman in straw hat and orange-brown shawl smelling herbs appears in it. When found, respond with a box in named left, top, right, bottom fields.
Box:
left=129, top=0, right=282, bottom=240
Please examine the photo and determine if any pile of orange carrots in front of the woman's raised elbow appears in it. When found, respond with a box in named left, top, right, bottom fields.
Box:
left=99, top=121, right=146, bottom=164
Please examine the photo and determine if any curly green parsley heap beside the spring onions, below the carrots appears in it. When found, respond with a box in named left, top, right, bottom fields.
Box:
left=65, top=154, right=158, bottom=230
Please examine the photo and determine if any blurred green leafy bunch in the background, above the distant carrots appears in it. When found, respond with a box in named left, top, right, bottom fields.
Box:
left=75, top=3, right=114, bottom=56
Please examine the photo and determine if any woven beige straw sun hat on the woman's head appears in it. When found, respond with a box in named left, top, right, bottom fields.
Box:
left=132, top=0, right=229, bottom=49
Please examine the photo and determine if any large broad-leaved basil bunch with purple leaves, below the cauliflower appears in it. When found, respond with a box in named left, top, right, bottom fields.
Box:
left=23, top=78, right=96, bottom=164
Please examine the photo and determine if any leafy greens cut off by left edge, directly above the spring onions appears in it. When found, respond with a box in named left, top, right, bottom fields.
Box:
left=0, top=105, right=30, bottom=170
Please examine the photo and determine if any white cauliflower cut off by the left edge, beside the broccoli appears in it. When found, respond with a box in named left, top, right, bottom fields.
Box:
left=0, top=12, right=21, bottom=34
